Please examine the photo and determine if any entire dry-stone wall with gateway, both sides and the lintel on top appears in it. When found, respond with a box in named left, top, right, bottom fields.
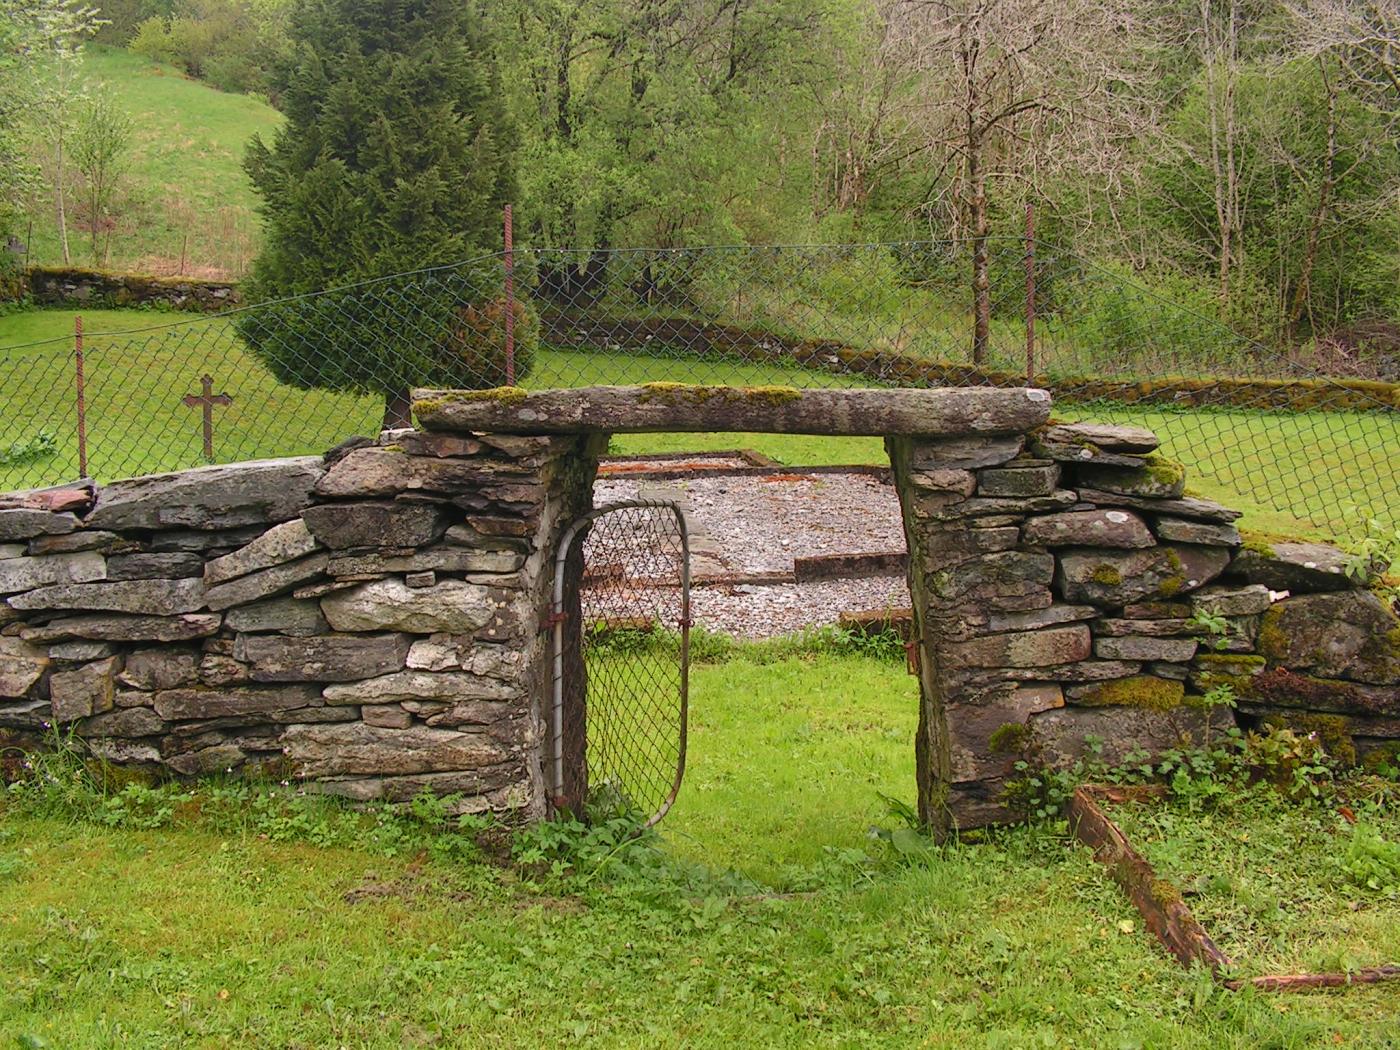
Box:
left=0, top=385, right=1400, bottom=832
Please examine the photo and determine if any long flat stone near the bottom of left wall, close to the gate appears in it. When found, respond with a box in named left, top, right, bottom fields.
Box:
left=283, top=722, right=511, bottom=777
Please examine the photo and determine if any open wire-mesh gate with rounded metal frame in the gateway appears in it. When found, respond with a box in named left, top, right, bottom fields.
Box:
left=550, top=500, right=690, bottom=826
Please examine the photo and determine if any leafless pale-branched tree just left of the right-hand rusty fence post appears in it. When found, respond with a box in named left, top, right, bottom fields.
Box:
left=903, top=0, right=1134, bottom=364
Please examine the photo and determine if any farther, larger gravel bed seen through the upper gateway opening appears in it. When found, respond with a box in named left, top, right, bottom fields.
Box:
left=594, top=468, right=904, bottom=575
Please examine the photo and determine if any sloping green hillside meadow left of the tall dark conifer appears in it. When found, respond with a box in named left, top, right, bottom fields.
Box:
left=17, top=46, right=281, bottom=276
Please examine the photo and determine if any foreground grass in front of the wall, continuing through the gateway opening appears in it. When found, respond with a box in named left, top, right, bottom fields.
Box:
left=0, top=655, right=1400, bottom=1050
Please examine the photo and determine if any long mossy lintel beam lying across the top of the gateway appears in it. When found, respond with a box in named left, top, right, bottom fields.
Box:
left=413, top=384, right=1050, bottom=437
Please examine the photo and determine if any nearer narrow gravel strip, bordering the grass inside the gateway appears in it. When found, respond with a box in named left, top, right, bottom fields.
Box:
left=690, top=575, right=909, bottom=638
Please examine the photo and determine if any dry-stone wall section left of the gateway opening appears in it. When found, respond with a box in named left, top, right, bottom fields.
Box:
left=0, top=431, right=595, bottom=818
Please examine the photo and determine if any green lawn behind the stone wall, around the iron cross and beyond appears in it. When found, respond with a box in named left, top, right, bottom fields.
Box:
left=0, top=302, right=1400, bottom=536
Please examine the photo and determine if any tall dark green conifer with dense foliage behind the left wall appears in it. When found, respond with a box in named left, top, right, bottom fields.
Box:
left=238, top=0, right=528, bottom=426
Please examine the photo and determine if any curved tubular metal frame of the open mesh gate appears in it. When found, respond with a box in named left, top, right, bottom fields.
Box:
left=550, top=500, right=692, bottom=827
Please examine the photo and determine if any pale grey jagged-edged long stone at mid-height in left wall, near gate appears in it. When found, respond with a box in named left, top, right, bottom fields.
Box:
left=321, top=580, right=510, bottom=634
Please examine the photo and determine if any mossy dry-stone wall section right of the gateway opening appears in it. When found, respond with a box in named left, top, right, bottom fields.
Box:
left=888, top=424, right=1400, bottom=827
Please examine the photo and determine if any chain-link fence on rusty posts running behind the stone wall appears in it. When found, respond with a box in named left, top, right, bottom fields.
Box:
left=0, top=241, right=1400, bottom=536
